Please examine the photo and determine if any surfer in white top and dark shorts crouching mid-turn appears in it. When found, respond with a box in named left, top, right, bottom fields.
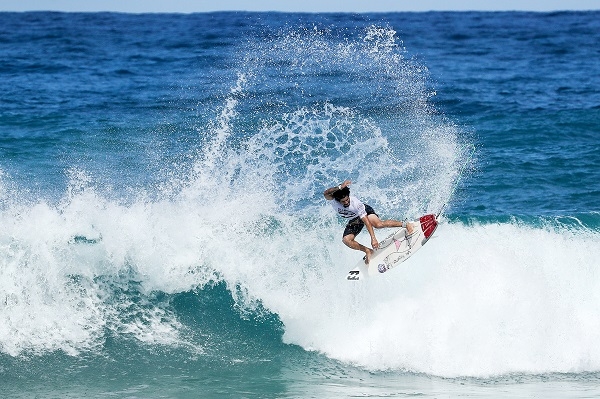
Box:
left=323, top=180, right=414, bottom=263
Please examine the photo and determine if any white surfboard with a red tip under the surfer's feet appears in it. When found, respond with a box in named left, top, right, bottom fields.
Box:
left=346, top=214, right=438, bottom=281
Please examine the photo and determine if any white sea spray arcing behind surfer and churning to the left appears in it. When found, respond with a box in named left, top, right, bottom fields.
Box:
left=1, top=22, right=468, bottom=355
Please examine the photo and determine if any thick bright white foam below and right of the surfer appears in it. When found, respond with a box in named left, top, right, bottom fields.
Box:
left=266, top=223, right=600, bottom=376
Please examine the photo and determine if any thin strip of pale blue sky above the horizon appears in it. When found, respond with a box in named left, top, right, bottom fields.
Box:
left=0, top=0, right=600, bottom=13
